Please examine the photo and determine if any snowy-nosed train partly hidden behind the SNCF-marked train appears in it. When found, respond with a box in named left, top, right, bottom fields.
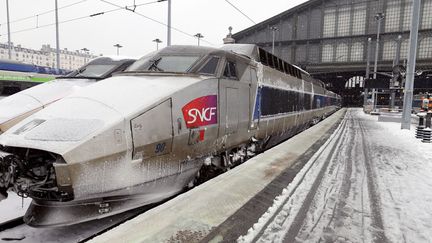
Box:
left=0, top=57, right=135, bottom=134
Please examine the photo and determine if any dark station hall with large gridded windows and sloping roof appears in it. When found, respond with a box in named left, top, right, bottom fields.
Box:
left=233, top=0, right=432, bottom=104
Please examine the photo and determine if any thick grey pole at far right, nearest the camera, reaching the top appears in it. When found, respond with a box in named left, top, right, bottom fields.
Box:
left=401, top=0, right=421, bottom=130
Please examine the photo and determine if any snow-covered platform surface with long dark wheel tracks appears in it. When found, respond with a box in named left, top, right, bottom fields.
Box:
left=238, top=109, right=432, bottom=242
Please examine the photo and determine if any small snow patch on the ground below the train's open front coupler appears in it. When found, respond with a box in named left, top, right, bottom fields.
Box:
left=0, top=192, right=31, bottom=223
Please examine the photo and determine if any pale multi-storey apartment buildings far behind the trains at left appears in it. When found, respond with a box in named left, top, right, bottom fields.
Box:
left=0, top=43, right=96, bottom=70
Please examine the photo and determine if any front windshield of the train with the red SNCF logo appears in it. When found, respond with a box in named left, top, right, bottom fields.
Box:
left=126, top=56, right=200, bottom=73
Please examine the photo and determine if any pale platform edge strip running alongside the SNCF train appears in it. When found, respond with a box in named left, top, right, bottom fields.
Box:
left=92, top=110, right=345, bottom=242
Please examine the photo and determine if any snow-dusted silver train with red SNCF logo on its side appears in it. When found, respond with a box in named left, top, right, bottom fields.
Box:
left=0, top=44, right=340, bottom=226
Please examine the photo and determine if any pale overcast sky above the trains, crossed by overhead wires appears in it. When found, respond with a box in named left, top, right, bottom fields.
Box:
left=0, top=0, right=306, bottom=57
